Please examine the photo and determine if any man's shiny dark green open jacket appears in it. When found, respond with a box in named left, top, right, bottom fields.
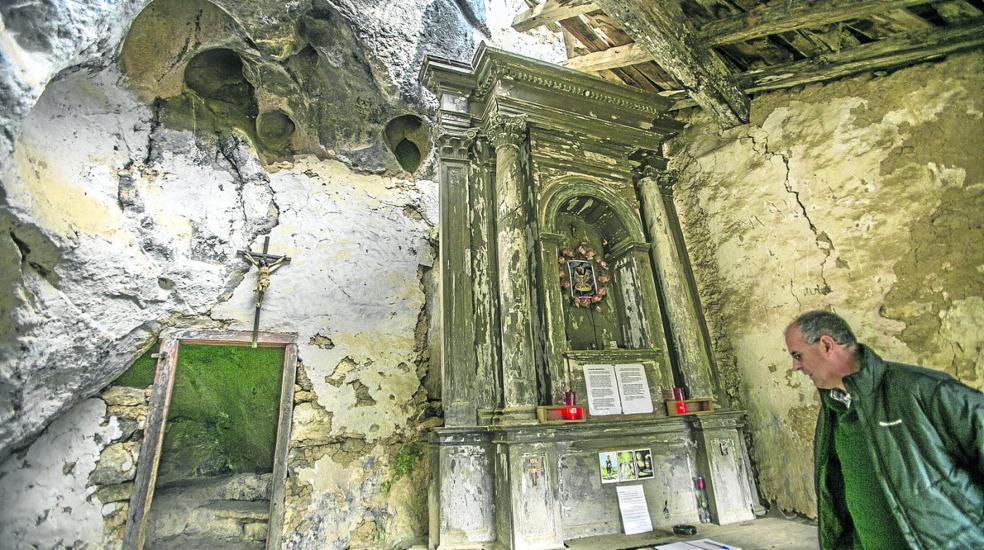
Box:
left=814, top=345, right=984, bottom=549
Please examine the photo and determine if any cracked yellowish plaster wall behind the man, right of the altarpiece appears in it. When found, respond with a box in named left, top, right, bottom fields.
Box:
left=667, top=52, right=984, bottom=515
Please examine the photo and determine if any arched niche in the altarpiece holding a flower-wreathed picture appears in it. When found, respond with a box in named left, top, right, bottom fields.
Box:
left=540, top=180, right=661, bottom=351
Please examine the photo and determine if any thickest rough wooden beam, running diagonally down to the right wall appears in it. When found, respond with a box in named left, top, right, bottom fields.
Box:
left=595, top=0, right=748, bottom=127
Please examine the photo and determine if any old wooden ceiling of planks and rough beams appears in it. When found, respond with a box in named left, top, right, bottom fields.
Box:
left=513, top=0, right=984, bottom=127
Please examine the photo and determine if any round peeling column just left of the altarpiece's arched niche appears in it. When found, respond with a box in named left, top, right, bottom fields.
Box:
left=487, top=115, right=537, bottom=417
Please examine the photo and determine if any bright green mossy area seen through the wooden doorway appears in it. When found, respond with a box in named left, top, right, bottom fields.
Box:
left=158, top=345, right=284, bottom=484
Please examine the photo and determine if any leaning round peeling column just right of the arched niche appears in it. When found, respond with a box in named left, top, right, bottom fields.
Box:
left=636, top=165, right=718, bottom=397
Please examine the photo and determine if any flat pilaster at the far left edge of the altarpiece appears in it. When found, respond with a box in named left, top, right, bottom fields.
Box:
left=437, top=128, right=477, bottom=426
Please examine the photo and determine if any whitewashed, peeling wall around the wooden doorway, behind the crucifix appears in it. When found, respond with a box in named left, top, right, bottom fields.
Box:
left=0, top=61, right=437, bottom=548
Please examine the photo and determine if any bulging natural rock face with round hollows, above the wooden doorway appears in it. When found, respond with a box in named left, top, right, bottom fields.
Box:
left=0, top=0, right=562, bottom=458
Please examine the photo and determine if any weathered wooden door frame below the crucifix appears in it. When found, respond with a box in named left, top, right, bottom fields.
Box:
left=123, top=329, right=297, bottom=550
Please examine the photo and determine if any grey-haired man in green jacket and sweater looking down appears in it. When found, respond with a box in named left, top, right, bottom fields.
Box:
left=785, top=311, right=984, bottom=549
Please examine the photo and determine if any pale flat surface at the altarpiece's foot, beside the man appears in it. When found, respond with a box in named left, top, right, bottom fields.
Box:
left=565, top=517, right=820, bottom=550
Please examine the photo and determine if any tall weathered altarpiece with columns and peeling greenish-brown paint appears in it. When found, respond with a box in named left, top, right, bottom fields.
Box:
left=421, top=45, right=758, bottom=549
